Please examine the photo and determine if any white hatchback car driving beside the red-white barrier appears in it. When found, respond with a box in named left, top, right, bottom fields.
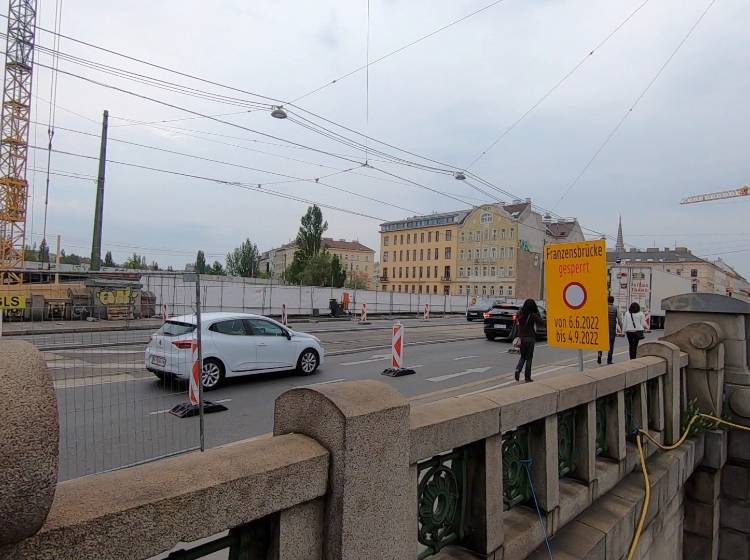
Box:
left=145, top=313, right=325, bottom=389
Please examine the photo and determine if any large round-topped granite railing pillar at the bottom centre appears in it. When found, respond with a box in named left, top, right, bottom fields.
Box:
left=274, top=381, right=417, bottom=560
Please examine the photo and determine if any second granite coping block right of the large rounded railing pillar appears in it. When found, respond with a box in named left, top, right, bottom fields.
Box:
left=482, top=383, right=558, bottom=432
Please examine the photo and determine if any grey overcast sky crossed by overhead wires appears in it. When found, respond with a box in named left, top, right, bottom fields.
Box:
left=23, top=0, right=750, bottom=277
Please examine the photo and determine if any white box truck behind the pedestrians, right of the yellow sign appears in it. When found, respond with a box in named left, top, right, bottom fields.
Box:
left=609, top=266, right=691, bottom=329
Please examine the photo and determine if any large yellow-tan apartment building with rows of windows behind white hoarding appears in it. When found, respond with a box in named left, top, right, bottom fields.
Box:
left=379, top=199, right=583, bottom=298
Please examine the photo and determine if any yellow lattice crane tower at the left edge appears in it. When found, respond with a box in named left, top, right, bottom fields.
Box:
left=0, top=0, right=36, bottom=285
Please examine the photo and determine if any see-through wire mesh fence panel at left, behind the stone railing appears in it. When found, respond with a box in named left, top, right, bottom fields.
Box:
left=0, top=271, right=200, bottom=480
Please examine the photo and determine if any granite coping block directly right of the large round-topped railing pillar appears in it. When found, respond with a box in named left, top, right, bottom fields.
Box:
left=410, top=395, right=500, bottom=463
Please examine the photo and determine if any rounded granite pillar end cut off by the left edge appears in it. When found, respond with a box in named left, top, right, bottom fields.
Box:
left=0, top=341, right=59, bottom=545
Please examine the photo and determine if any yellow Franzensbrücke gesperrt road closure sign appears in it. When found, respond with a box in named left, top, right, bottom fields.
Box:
left=544, top=241, right=609, bottom=350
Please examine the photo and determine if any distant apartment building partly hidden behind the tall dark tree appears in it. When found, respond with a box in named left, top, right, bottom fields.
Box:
left=268, top=237, right=375, bottom=289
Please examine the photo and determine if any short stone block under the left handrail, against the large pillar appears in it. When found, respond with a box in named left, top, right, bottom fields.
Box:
left=278, top=499, right=325, bottom=560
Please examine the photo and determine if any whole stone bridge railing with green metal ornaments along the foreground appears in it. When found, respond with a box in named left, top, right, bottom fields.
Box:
left=0, top=298, right=740, bottom=560
